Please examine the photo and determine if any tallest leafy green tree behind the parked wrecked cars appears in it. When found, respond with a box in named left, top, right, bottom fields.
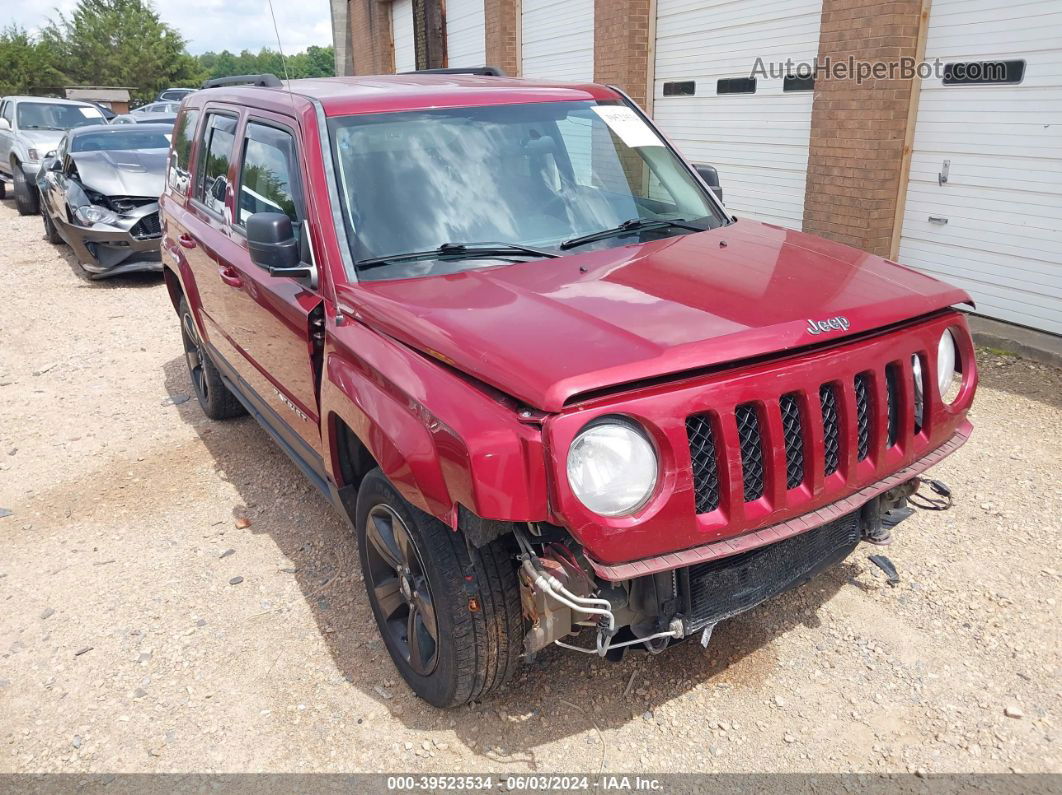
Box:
left=42, top=0, right=202, bottom=102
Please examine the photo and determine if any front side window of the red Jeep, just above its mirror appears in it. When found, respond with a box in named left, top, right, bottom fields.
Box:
left=237, top=122, right=306, bottom=229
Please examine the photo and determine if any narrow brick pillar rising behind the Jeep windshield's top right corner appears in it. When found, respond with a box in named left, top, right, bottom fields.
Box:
left=594, top=0, right=651, bottom=107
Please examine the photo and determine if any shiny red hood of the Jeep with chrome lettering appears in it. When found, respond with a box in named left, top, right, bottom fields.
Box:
left=343, top=221, right=970, bottom=411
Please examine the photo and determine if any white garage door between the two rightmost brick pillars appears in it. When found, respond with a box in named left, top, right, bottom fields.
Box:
left=653, top=0, right=822, bottom=229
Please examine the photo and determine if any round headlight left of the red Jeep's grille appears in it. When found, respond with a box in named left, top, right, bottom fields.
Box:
left=567, top=419, right=658, bottom=516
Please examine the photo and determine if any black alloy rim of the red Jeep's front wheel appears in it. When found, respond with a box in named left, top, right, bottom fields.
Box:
left=365, top=503, right=439, bottom=676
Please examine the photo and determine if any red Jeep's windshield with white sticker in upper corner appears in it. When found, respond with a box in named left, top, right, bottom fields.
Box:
left=329, top=102, right=725, bottom=279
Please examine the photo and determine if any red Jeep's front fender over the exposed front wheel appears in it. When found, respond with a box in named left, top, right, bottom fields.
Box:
left=321, top=321, right=549, bottom=526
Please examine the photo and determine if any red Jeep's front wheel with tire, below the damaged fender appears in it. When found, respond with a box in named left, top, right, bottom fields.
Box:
left=355, top=468, right=526, bottom=707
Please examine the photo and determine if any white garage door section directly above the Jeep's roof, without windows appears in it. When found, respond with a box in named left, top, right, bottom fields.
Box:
left=520, top=0, right=594, bottom=82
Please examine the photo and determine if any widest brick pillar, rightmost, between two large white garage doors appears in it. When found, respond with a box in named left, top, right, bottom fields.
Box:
left=804, top=0, right=922, bottom=257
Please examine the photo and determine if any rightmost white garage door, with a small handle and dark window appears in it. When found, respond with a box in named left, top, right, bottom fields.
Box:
left=900, top=0, right=1062, bottom=334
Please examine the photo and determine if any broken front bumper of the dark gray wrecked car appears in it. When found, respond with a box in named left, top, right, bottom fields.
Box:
left=54, top=204, right=162, bottom=278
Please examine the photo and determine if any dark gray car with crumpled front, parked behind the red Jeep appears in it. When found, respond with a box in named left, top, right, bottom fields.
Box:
left=37, top=124, right=172, bottom=278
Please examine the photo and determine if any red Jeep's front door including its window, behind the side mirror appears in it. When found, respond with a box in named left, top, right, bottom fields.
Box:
left=207, top=110, right=321, bottom=458
